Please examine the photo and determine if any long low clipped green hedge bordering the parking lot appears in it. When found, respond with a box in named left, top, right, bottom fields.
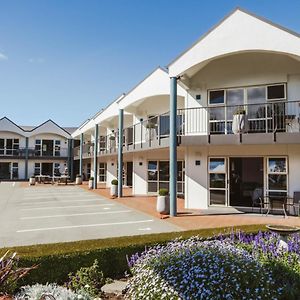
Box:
left=0, top=225, right=265, bottom=285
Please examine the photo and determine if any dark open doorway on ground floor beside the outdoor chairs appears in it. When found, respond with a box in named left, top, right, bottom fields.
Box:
left=229, top=157, right=264, bottom=207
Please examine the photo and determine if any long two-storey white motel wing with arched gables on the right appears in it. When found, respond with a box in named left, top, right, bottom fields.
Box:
left=72, top=9, right=300, bottom=216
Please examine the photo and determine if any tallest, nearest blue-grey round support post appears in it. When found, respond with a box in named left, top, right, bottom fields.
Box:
left=169, top=77, right=177, bottom=217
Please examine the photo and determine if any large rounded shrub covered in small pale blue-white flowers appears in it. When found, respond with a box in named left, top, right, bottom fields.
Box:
left=126, top=238, right=282, bottom=299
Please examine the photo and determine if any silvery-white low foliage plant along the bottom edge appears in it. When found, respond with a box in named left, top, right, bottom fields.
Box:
left=14, top=283, right=93, bottom=300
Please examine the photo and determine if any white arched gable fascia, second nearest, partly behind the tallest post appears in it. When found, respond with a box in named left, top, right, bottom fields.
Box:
left=119, top=68, right=185, bottom=109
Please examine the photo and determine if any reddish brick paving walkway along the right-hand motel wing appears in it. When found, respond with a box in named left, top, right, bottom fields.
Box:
left=82, top=184, right=300, bottom=230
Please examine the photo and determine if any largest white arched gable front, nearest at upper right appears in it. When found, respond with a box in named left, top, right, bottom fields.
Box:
left=169, top=10, right=300, bottom=77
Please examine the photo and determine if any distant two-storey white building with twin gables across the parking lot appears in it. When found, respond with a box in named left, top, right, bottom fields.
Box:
left=0, top=117, right=75, bottom=181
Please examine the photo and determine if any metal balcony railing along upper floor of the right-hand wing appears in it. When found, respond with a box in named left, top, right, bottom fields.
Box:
left=75, top=101, right=300, bottom=156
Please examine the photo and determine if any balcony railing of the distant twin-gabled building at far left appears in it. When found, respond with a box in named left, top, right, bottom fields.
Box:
left=0, top=148, right=68, bottom=158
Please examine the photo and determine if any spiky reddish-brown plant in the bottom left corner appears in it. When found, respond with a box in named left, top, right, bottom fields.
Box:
left=0, top=251, right=37, bottom=294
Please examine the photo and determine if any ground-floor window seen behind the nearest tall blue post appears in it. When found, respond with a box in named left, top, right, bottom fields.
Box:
left=148, top=160, right=184, bottom=194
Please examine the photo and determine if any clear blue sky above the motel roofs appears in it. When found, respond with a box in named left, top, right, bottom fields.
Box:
left=0, top=0, right=300, bottom=126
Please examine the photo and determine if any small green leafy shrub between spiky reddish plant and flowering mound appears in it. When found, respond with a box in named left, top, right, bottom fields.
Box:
left=67, top=260, right=107, bottom=297
